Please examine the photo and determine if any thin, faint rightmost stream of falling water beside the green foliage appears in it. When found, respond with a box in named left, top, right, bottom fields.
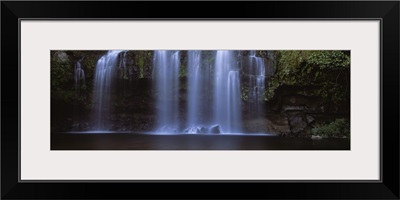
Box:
left=248, top=51, right=265, bottom=116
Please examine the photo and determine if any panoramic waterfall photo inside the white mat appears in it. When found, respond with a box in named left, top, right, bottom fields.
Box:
left=50, top=50, right=350, bottom=150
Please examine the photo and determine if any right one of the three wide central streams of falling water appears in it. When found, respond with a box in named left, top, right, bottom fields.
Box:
left=213, top=51, right=241, bottom=133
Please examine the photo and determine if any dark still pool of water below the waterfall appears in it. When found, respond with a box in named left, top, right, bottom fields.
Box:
left=51, top=131, right=350, bottom=150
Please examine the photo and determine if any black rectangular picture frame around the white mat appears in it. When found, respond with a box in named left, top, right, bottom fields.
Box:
left=1, top=1, right=400, bottom=199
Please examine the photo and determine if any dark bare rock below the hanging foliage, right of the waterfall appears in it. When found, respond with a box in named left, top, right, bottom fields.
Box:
left=258, top=86, right=350, bottom=136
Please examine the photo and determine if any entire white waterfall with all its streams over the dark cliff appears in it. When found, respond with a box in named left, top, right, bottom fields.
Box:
left=86, top=50, right=268, bottom=133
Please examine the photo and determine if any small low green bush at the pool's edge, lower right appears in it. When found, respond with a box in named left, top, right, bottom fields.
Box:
left=311, top=119, right=350, bottom=137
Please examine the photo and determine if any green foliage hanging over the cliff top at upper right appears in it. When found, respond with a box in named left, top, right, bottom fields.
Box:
left=265, top=50, right=350, bottom=103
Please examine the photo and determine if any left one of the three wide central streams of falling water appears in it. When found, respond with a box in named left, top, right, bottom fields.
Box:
left=153, top=51, right=180, bottom=132
